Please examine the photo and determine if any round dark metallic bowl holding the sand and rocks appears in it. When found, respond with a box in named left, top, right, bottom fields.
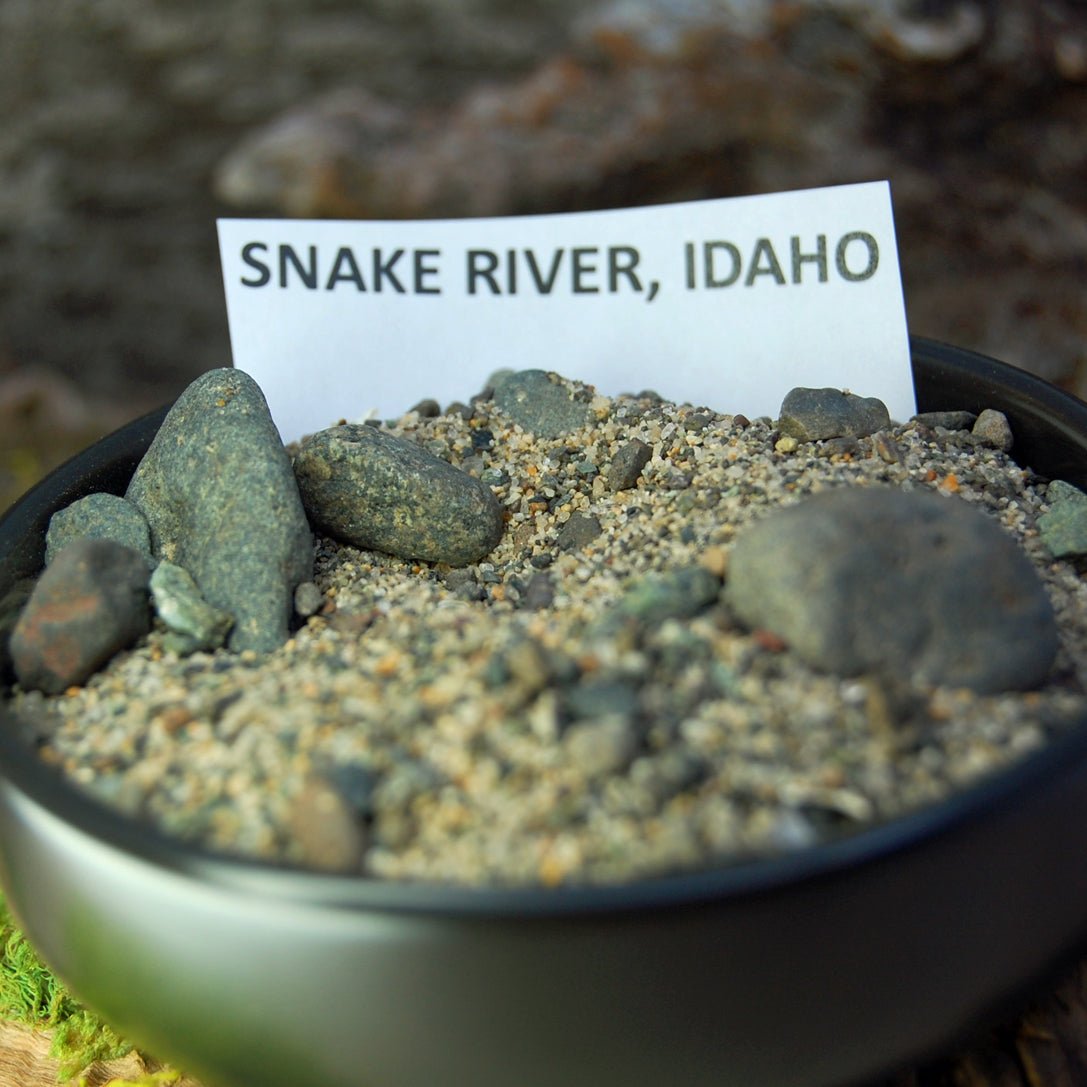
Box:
left=0, top=341, right=1087, bottom=1087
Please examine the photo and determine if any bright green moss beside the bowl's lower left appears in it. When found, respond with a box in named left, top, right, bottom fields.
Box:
left=0, top=898, right=133, bottom=1087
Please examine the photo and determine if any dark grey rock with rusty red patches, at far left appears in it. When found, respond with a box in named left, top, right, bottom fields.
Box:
left=11, top=539, right=151, bottom=695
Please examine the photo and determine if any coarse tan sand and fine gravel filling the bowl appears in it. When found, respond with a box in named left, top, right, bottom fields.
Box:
left=13, top=378, right=1087, bottom=885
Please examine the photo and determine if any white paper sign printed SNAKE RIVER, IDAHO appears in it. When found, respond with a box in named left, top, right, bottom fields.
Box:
left=218, top=182, right=915, bottom=440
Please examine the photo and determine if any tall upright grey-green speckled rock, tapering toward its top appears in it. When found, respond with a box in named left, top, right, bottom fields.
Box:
left=125, top=370, right=313, bottom=652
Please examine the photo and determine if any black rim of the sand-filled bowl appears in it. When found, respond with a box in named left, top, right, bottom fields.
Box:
left=0, top=337, right=1087, bottom=921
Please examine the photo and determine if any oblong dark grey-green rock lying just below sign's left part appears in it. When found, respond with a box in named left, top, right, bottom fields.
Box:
left=295, top=423, right=503, bottom=566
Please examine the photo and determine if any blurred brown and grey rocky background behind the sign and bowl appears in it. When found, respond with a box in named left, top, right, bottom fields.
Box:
left=0, top=0, right=1087, bottom=505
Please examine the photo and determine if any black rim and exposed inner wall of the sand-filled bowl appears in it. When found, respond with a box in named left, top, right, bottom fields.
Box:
left=0, top=338, right=1087, bottom=914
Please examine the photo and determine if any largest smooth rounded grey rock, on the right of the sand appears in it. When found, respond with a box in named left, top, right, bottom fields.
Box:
left=726, top=487, right=1058, bottom=692
